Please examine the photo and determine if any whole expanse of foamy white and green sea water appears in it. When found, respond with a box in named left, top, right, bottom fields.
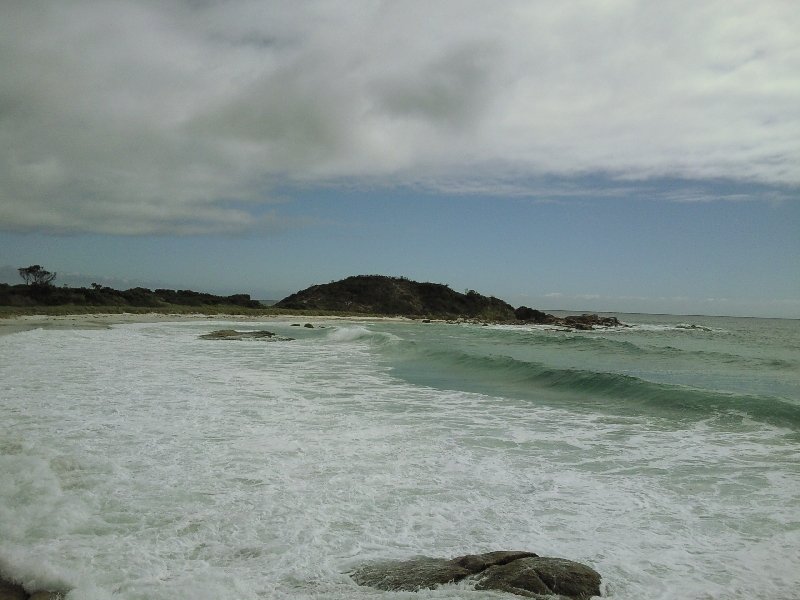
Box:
left=0, top=315, right=800, bottom=600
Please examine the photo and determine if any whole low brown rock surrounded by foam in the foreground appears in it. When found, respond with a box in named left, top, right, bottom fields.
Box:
left=350, top=551, right=600, bottom=600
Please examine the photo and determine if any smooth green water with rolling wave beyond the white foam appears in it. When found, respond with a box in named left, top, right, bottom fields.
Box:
left=382, top=315, right=800, bottom=425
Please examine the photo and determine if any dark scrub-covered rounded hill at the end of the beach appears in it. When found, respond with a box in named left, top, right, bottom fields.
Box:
left=275, top=275, right=515, bottom=321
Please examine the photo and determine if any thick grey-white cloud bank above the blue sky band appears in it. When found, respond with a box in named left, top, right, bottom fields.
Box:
left=0, top=0, right=800, bottom=234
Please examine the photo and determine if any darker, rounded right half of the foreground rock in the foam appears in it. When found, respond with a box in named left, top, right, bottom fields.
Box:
left=475, top=557, right=600, bottom=600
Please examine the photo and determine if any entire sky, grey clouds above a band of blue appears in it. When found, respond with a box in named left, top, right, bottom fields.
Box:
left=0, top=0, right=800, bottom=318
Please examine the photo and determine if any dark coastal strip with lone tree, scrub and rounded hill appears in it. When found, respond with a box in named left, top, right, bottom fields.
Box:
left=0, top=265, right=620, bottom=329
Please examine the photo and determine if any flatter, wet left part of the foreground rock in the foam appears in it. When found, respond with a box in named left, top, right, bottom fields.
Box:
left=351, top=556, right=472, bottom=592
